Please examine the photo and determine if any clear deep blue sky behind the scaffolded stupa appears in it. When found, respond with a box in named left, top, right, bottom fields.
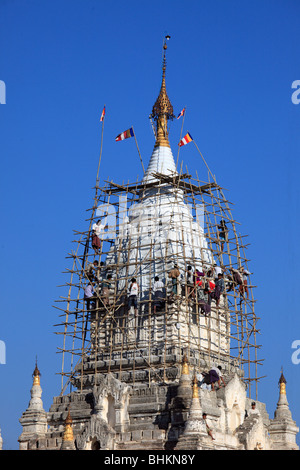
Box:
left=0, top=0, right=300, bottom=449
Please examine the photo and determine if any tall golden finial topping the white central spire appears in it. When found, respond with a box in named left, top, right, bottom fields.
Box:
left=151, top=36, right=175, bottom=147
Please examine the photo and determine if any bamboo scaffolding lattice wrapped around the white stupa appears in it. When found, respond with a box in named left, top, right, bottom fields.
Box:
left=55, top=163, right=262, bottom=396
